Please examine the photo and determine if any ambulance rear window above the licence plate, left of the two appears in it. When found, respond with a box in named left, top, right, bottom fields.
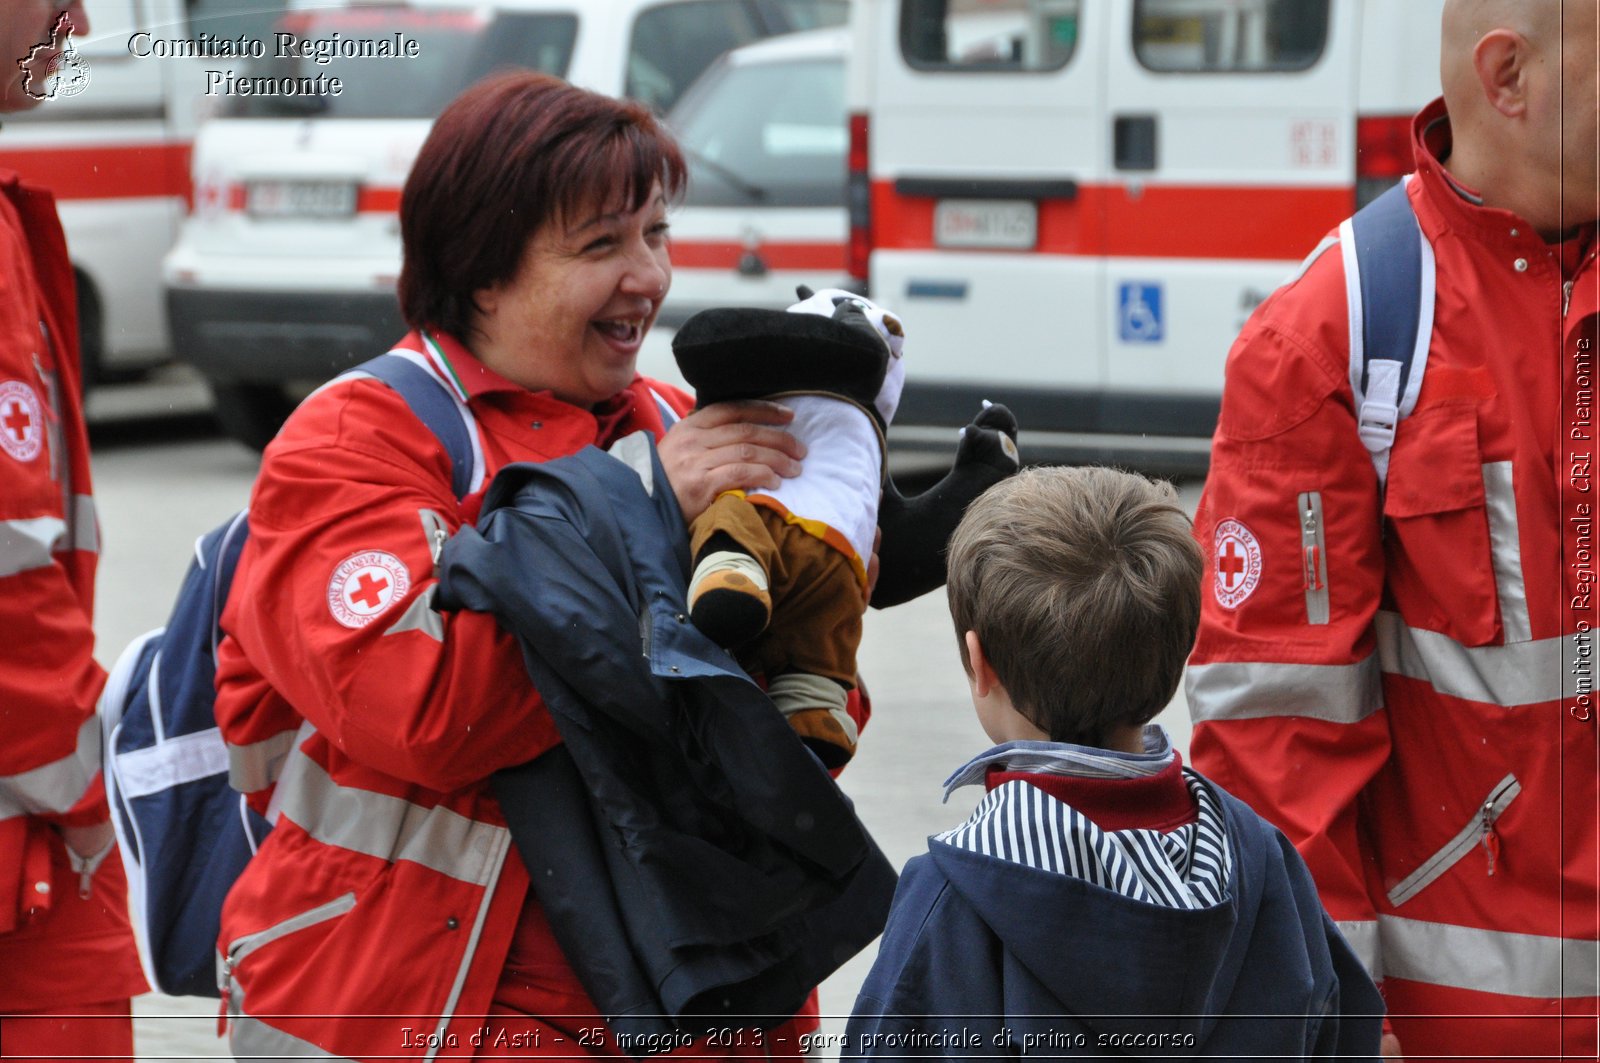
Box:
left=901, top=0, right=1082, bottom=70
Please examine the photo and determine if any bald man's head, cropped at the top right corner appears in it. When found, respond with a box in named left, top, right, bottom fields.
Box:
left=1440, top=0, right=1600, bottom=234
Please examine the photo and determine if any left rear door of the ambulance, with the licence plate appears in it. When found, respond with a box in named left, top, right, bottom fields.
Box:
left=856, top=0, right=1109, bottom=424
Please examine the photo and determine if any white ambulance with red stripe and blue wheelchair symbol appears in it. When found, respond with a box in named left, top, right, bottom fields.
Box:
left=848, top=0, right=1443, bottom=471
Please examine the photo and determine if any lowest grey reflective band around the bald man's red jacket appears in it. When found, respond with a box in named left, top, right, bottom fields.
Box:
left=1378, top=916, right=1600, bottom=1001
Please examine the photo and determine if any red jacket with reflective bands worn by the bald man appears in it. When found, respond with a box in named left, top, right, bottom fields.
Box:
left=1187, top=101, right=1600, bottom=1057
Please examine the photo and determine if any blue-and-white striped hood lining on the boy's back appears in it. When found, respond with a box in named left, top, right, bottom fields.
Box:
left=934, top=768, right=1234, bottom=911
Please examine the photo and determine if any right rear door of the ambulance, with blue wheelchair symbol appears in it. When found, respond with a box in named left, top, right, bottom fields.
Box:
left=1098, top=0, right=1358, bottom=413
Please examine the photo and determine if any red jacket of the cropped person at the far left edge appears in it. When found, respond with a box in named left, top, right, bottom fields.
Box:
left=0, top=171, right=144, bottom=1012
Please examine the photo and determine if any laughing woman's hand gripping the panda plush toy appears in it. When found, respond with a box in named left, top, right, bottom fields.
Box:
left=656, top=400, right=805, bottom=520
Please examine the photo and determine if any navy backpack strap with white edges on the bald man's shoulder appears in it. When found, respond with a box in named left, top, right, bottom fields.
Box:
left=1339, top=178, right=1435, bottom=491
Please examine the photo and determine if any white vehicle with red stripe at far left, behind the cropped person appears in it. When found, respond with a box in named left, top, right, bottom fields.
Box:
left=0, top=0, right=283, bottom=381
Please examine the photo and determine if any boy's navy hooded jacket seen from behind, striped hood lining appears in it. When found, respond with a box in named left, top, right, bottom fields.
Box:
left=842, top=773, right=1384, bottom=1060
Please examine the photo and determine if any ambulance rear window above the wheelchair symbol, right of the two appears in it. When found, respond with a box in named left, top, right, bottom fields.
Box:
left=1133, top=0, right=1328, bottom=74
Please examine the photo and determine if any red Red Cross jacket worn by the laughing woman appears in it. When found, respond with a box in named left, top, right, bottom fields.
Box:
left=216, top=333, right=832, bottom=1058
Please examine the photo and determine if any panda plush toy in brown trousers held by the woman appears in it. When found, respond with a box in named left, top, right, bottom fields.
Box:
left=672, top=288, right=1019, bottom=768
